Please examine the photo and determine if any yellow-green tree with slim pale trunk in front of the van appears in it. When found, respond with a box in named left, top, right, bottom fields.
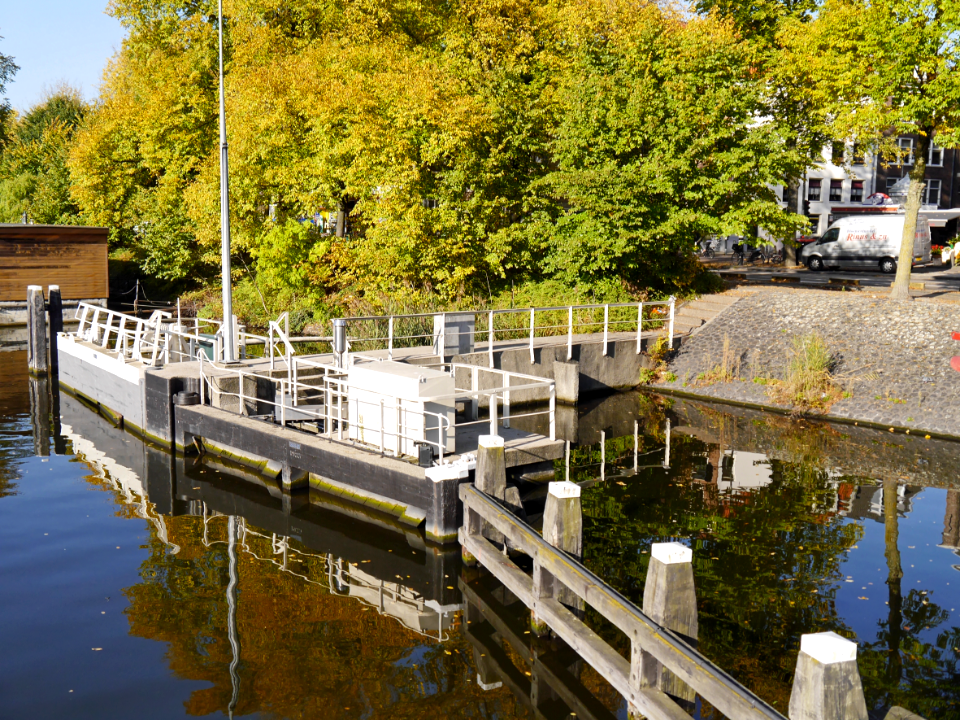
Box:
left=782, top=0, right=960, bottom=300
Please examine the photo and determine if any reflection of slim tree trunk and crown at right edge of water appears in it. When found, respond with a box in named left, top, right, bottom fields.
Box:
left=860, top=481, right=960, bottom=718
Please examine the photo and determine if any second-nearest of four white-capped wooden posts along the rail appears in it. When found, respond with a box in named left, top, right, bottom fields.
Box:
left=630, top=542, right=698, bottom=717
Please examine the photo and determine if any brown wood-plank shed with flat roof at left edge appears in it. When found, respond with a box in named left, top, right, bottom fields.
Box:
left=0, top=224, right=109, bottom=302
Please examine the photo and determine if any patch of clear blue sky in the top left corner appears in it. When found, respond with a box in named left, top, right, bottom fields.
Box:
left=0, top=0, right=124, bottom=112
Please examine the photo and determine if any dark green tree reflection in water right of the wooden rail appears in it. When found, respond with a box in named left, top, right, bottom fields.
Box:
left=583, top=436, right=862, bottom=710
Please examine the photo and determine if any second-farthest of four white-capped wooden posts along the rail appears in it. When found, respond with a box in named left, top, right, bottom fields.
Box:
left=530, top=480, right=583, bottom=635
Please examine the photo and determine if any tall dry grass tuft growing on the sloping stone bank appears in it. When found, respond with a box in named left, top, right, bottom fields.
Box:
left=767, top=333, right=842, bottom=415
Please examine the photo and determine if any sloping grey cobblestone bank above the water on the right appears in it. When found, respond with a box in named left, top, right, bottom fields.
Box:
left=660, top=289, right=960, bottom=436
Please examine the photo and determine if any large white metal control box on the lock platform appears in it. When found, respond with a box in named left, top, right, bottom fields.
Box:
left=347, top=360, right=456, bottom=457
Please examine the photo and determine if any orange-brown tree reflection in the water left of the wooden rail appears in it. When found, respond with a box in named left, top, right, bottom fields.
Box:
left=125, top=517, right=528, bottom=718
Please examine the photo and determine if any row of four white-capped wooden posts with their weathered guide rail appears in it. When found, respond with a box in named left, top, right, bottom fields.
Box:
left=461, top=436, right=884, bottom=720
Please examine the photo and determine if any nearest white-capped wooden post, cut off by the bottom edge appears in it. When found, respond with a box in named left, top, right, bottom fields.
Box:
left=788, top=632, right=867, bottom=720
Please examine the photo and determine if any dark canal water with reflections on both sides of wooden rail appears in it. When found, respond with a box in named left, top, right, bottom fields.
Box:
left=0, top=352, right=960, bottom=720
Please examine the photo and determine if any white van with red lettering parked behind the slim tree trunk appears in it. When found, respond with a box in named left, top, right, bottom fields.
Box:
left=800, top=215, right=930, bottom=273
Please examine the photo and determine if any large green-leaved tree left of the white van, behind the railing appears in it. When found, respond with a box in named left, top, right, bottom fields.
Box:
left=537, top=5, right=805, bottom=287
